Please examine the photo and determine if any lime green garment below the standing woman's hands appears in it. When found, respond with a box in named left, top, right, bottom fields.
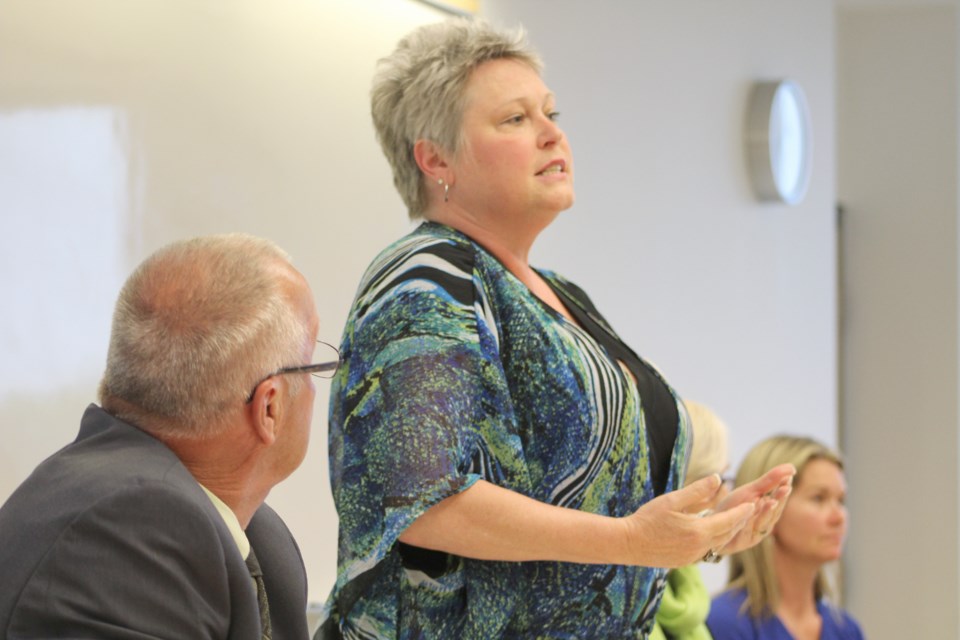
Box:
left=649, top=564, right=712, bottom=640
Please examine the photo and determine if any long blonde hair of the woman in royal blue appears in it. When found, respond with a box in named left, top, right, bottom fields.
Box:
left=728, top=435, right=843, bottom=618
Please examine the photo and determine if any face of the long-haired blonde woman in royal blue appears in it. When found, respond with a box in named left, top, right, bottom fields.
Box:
left=773, top=459, right=847, bottom=565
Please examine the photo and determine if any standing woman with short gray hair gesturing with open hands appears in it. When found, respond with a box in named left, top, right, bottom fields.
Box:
left=320, top=20, right=794, bottom=640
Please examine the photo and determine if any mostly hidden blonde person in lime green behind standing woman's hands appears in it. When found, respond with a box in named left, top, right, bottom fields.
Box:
left=650, top=400, right=730, bottom=640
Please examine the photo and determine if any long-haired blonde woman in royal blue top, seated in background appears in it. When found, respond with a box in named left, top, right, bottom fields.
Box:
left=707, top=436, right=863, bottom=640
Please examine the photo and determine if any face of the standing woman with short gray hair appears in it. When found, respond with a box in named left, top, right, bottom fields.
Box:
left=450, top=59, right=573, bottom=227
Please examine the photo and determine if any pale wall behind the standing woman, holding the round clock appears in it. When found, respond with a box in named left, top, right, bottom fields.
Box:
left=0, top=0, right=837, bottom=600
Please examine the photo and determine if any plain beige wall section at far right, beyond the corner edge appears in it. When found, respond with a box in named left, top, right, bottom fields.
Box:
left=837, top=1, right=960, bottom=639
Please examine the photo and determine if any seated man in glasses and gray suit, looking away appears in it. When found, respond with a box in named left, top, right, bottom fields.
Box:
left=0, top=234, right=330, bottom=640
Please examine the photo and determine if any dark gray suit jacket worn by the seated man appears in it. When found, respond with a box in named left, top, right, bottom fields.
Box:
left=0, top=405, right=308, bottom=640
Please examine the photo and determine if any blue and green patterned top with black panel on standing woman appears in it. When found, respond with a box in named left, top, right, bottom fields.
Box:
left=318, top=223, right=690, bottom=640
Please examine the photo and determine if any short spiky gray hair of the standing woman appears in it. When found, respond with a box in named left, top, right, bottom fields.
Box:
left=370, top=18, right=543, bottom=219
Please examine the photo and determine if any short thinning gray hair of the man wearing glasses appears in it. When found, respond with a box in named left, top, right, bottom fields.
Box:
left=100, top=234, right=310, bottom=437
